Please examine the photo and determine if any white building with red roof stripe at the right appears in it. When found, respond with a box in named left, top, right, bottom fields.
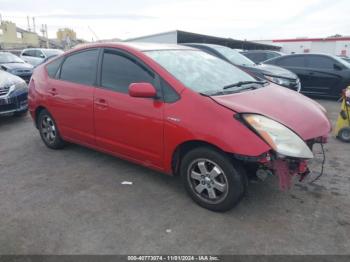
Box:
left=257, top=36, right=350, bottom=56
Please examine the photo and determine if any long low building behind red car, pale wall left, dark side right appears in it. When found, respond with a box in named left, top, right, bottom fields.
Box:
left=125, top=30, right=280, bottom=50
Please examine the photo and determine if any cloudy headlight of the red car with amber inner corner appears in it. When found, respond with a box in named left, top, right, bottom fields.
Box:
left=243, top=114, right=314, bottom=159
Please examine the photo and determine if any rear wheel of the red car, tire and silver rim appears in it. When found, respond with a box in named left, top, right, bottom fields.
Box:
left=38, top=109, right=65, bottom=149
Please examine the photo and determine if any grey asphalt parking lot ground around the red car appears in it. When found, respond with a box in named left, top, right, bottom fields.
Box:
left=0, top=100, right=350, bottom=254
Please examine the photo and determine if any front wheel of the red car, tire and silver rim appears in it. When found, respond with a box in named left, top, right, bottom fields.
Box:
left=180, top=147, right=246, bottom=212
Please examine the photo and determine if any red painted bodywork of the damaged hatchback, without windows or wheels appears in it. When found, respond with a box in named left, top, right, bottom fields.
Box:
left=29, top=44, right=330, bottom=174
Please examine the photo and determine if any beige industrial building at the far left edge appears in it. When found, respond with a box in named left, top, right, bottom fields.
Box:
left=0, top=21, right=40, bottom=49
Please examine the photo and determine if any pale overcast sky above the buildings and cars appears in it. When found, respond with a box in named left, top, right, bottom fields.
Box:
left=0, top=0, right=350, bottom=41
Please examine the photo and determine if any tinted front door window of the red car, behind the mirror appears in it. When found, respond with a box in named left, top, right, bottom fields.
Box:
left=101, top=50, right=154, bottom=93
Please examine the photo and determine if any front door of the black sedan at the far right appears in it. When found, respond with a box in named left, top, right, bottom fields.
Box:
left=305, top=55, right=342, bottom=95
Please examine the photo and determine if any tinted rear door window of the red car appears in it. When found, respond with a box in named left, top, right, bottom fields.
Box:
left=60, top=49, right=99, bottom=85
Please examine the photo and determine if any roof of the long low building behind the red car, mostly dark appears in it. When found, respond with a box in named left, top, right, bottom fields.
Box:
left=125, top=30, right=281, bottom=50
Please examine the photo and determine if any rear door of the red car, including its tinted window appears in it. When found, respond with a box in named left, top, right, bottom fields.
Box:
left=47, top=49, right=99, bottom=145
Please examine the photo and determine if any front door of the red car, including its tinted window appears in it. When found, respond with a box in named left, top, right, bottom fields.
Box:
left=94, top=49, right=164, bottom=168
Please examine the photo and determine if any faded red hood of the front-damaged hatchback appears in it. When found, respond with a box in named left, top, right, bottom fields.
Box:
left=212, top=84, right=331, bottom=140
